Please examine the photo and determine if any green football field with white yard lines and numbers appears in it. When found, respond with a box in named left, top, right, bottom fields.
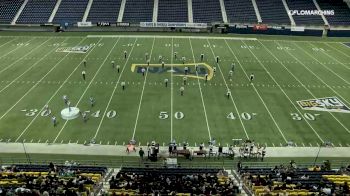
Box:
left=0, top=33, right=350, bottom=150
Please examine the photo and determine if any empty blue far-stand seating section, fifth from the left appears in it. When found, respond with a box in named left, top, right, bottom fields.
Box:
left=123, top=0, right=154, bottom=23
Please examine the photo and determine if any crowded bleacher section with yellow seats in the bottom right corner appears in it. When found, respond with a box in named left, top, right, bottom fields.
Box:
left=240, top=163, right=350, bottom=196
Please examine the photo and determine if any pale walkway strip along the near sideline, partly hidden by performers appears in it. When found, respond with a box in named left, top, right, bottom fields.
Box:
left=0, top=142, right=350, bottom=158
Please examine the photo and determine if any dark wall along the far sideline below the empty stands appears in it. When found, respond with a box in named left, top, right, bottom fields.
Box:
left=0, top=24, right=350, bottom=37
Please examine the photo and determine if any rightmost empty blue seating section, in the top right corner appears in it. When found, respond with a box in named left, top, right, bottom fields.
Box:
left=317, top=0, right=350, bottom=25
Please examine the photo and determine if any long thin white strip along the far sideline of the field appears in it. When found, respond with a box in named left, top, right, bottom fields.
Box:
left=87, top=35, right=257, bottom=40
